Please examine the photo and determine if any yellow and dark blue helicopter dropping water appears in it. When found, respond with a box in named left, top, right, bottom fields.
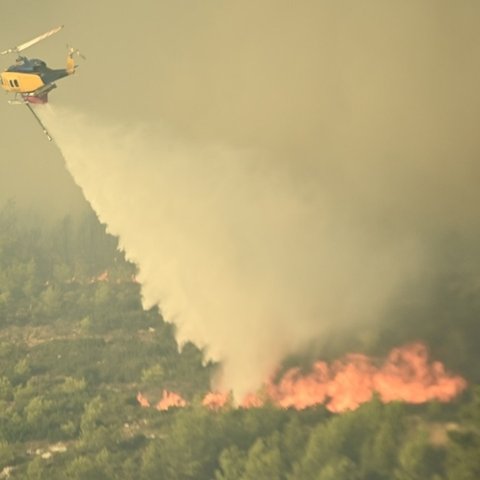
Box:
left=0, top=25, right=85, bottom=141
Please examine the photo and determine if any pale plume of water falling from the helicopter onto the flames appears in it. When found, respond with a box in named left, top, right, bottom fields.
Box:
left=41, top=109, right=419, bottom=394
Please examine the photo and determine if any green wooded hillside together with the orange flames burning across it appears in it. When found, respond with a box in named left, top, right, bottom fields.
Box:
left=0, top=204, right=480, bottom=480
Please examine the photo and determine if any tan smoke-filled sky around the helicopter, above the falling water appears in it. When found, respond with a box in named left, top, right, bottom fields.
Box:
left=0, top=0, right=480, bottom=219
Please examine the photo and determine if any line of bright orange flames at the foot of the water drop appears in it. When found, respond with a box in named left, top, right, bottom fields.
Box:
left=137, top=342, right=467, bottom=412
